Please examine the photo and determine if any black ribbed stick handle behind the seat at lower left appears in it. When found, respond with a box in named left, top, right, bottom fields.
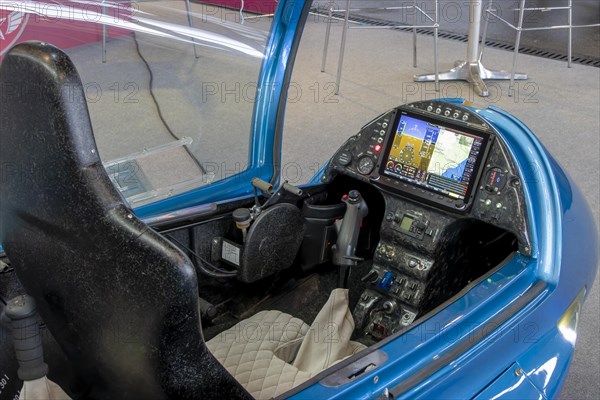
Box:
left=6, top=295, right=48, bottom=381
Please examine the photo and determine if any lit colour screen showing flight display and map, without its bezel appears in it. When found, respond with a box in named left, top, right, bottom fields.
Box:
left=381, top=113, right=487, bottom=203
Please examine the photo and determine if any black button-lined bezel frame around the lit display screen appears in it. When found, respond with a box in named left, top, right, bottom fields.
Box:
left=378, top=109, right=493, bottom=211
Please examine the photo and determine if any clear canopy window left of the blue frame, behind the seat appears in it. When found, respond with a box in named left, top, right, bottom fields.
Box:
left=0, top=0, right=275, bottom=207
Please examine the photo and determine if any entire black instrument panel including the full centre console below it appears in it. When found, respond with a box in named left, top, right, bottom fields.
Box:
left=322, top=101, right=531, bottom=340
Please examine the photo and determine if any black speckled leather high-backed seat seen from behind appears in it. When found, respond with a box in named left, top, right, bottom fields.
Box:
left=0, top=42, right=249, bottom=400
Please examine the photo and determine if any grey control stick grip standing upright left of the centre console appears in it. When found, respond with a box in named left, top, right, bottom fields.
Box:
left=333, top=190, right=369, bottom=288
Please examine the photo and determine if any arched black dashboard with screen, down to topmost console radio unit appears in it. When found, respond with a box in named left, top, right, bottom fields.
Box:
left=322, top=100, right=530, bottom=255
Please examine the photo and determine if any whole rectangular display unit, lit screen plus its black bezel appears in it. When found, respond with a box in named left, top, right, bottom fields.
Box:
left=379, top=110, right=490, bottom=210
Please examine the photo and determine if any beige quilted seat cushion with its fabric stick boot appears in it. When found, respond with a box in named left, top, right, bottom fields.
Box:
left=207, top=289, right=365, bottom=399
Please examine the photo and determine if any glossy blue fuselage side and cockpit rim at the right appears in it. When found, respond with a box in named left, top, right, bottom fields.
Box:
left=294, top=99, right=598, bottom=399
